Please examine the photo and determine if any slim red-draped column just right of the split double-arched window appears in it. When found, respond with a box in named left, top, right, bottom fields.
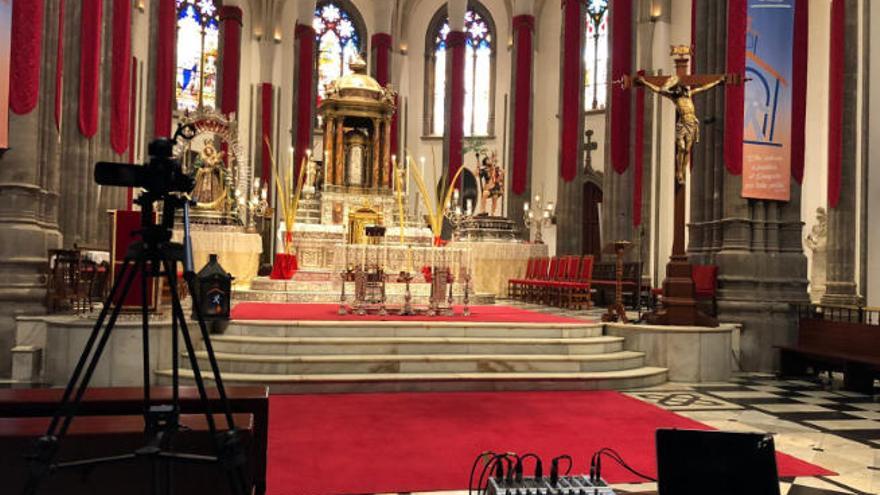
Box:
left=507, top=0, right=535, bottom=238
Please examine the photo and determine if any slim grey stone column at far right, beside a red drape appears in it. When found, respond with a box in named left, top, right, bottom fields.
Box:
left=822, top=0, right=861, bottom=304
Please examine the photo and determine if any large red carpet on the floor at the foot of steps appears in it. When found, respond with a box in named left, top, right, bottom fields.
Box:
left=269, top=392, right=833, bottom=495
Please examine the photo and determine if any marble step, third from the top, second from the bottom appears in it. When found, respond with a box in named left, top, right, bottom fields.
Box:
left=196, top=351, right=645, bottom=375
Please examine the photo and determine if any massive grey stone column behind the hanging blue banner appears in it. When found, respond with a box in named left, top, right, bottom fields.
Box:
left=688, top=2, right=808, bottom=371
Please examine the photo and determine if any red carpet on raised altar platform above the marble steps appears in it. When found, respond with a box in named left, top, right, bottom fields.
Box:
left=232, top=302, right=589, bottom=324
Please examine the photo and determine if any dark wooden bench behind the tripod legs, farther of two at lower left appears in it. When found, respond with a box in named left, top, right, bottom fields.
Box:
left=0, top=387, right=269, bottom=495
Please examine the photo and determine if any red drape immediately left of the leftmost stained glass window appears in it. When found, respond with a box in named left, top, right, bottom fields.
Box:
left=153, top=0, right=177, bottom=137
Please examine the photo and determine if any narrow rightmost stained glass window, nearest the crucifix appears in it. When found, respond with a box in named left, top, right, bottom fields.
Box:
left=584, top=0, right=608, bottom=110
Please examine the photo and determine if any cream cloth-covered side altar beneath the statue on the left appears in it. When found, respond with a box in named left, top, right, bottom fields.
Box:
left=172, top=224, right=263, bottom=286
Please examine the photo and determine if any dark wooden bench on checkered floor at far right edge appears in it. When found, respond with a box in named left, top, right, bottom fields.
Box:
left=777, top=318, right=880, bottom=395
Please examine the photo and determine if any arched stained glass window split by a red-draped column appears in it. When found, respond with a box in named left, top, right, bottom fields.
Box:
left=430, top=10, right=494, bottom=136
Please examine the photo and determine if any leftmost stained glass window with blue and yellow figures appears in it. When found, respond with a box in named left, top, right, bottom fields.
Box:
left=176, top=0, right=220, bottom=111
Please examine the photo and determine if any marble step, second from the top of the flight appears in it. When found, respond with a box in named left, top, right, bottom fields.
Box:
left=211, top=335, right=624, bottom=355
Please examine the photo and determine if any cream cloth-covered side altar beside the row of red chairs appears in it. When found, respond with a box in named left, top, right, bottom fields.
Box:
left=449, top=240, right=549, bottom=297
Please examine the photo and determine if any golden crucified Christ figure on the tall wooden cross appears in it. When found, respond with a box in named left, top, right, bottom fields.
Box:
left=636, top=72, right=735, bottom=185
